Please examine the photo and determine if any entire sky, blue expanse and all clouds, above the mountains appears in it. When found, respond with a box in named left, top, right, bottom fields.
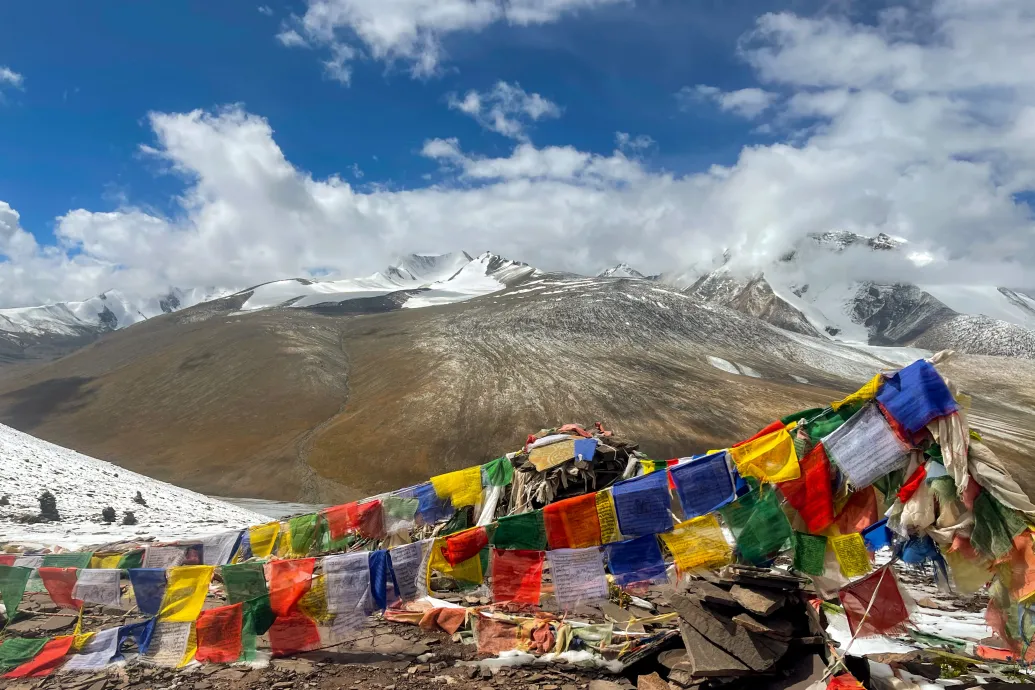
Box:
left=0, top=0, right=1035, bottom=306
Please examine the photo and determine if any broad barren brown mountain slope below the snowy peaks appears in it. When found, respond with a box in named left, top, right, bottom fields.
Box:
left=0, top=276, right=1035, bottom=502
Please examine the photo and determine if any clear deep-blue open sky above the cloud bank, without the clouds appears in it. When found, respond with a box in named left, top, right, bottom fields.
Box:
left=0, top=0, right=804, bottom=240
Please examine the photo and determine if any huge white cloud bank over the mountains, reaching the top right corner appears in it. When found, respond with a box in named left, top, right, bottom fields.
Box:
left=0, top=0, right=1035, bottom=306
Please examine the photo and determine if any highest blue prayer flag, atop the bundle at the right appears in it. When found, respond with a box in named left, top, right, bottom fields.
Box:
left=877, top=359, right=958, bottom=433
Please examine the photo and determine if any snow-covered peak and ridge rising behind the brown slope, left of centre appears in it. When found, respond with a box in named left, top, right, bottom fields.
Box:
left=238, top=251, right=536, bottom=311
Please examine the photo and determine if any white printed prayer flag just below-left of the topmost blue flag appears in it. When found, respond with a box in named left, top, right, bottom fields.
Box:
left=823, top=403, right=909, bottom=488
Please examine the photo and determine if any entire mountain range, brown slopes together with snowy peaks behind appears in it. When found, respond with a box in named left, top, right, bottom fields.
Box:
left=0, top=238, right=1035, bottom=503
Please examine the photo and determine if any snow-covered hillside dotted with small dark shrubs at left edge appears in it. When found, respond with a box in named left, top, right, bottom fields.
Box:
left=0, top=424, right=269, bottom=548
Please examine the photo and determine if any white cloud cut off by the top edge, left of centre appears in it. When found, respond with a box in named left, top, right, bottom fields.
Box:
left=282, top=0, right=630, bottom=77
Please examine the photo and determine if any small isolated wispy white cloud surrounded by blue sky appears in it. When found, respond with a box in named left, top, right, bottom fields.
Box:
left=447, top=82, right=561, bottom=140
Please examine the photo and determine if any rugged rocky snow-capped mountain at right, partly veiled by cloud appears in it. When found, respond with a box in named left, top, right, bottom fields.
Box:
left=663, top=231, right=1035, bottom=357
